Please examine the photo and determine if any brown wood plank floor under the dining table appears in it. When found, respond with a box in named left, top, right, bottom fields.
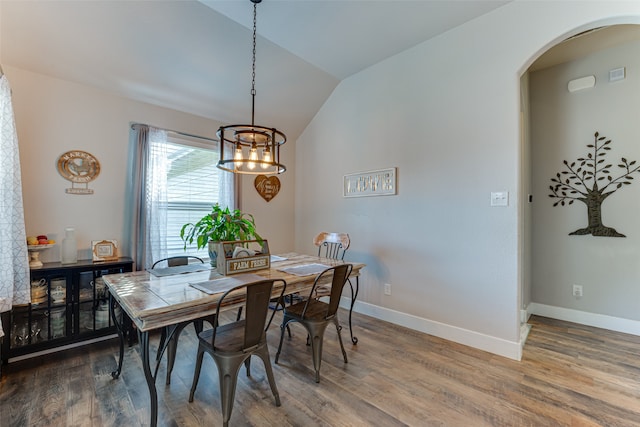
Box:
left=0, top=312, right=640, bottom=427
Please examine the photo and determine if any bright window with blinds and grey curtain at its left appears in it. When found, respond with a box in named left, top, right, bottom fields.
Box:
left=126, top=123, right=236, bottom=270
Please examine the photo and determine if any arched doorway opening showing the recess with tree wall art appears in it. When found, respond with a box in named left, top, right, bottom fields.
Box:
left=521, top=24, right=640, bottom=333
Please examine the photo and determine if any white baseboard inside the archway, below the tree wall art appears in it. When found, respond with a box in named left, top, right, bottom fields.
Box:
left=527, top=302, right=640, bottom=336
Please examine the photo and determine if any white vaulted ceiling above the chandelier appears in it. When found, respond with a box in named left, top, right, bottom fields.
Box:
left=0, top=0, right=508, bottom=139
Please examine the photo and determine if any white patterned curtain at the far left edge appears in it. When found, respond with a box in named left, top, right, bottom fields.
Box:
left=0, top=74, right=31, bottom=337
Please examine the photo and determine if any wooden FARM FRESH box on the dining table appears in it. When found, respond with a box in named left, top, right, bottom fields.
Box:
left=216, top=240, right=271, bottom=276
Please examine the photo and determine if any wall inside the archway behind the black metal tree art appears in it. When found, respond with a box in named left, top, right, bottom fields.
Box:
left=530, top=41, right=640, bottom=320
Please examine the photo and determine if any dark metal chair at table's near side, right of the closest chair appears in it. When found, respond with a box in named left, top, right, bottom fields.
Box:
left=275, top=264, right=353, bottom=382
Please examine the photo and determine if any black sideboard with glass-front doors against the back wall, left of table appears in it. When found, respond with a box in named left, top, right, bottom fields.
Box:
left=0, top=258, right=133, bottom=364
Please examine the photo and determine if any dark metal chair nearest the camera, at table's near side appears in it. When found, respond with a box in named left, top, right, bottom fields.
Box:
left=189, top=279, right=287, bottom=426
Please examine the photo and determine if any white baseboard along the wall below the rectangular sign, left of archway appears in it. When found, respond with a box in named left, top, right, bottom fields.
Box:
left=340, top=297, right=526, bottom=361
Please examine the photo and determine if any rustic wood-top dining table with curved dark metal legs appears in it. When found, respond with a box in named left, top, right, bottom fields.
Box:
left=103, top=252, right=365, bottom=427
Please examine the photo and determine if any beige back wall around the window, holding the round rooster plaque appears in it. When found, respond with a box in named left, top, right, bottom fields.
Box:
left=8, top=65, right=294, bottom=262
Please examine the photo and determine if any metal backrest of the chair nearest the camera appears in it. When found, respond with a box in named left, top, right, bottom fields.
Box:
left=212, top=279, right=287, bottom=350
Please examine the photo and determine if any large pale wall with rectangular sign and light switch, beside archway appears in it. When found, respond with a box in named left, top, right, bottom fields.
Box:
left=295, top=1, right=640, bottom=358
